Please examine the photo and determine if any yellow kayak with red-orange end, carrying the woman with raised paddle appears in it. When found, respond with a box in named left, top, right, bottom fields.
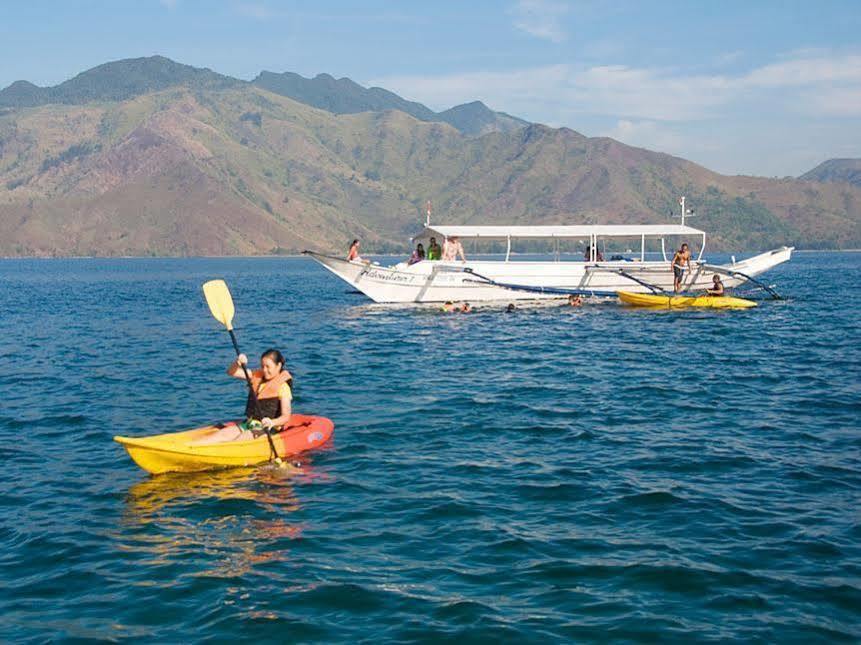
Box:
left=114, top=414, right=335, bottom=475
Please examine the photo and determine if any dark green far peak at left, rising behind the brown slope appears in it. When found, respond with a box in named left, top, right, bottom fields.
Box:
left=0, top=56, right=243, bottom=108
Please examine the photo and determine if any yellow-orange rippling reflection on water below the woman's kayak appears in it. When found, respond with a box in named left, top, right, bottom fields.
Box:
left=118, top=464, right=313, bottom=577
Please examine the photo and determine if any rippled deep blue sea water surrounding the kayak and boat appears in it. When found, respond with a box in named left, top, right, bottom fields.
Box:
left=0, top=253, right=861, bottom=642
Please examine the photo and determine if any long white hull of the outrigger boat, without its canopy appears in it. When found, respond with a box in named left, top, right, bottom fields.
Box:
left=306, top=247, right=793, bottom=303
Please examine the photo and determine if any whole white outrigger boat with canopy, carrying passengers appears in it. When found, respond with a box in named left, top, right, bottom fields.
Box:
left=305, top=211, right=794, bottom=303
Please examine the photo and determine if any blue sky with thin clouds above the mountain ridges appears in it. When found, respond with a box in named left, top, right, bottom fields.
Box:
left=0, top=0, right=861, bottom=176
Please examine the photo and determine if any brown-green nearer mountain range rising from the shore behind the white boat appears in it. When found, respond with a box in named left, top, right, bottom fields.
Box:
left=0, top=58, right=861, bottom=255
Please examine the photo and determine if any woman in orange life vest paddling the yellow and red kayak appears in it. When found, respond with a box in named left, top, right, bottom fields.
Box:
left=195, top=349, right=293, bottom=445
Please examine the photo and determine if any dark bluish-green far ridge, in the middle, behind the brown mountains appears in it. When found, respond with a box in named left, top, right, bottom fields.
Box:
left=252, top=72, right=528, bottom=135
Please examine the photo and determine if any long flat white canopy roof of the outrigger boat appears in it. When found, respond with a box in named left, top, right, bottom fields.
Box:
left=413, top=224, right=705, bottom=240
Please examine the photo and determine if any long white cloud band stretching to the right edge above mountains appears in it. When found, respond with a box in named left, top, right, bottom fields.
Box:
left=372, top=53, right=861, bottom=123
